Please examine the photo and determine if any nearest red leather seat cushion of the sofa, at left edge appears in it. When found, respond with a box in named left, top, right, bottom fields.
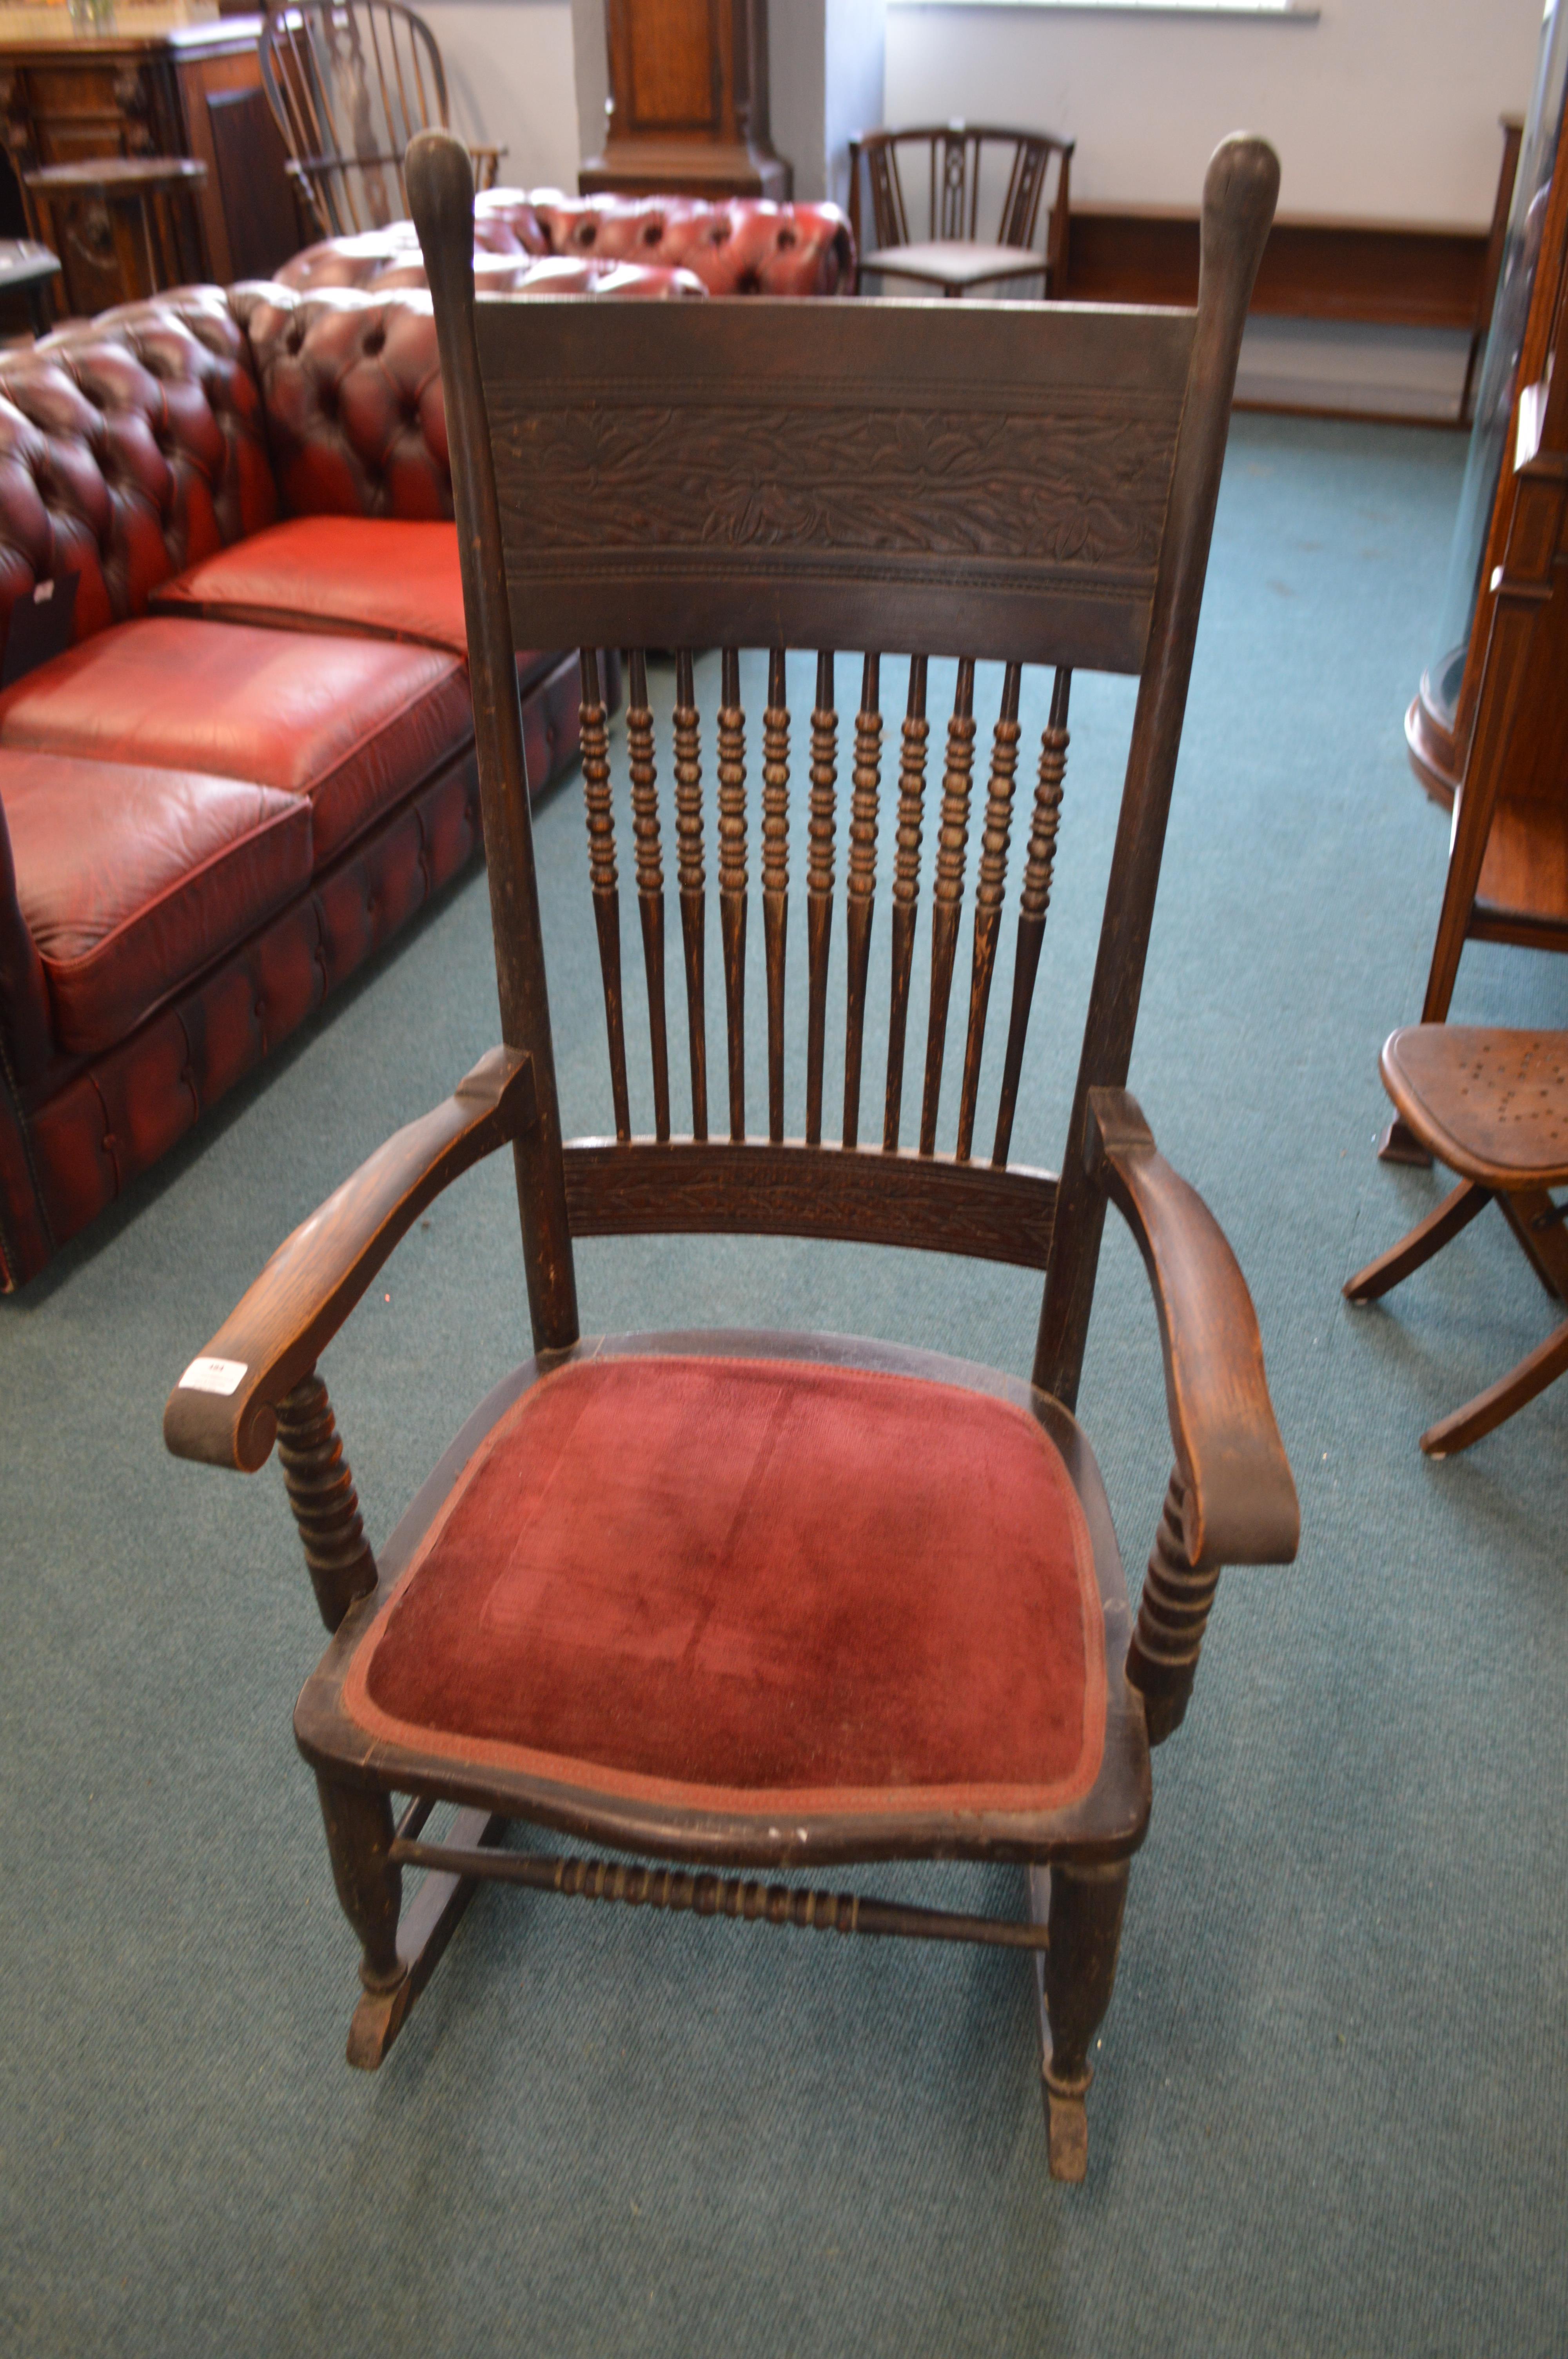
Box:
left=0, top=748, right=311, bottom=1057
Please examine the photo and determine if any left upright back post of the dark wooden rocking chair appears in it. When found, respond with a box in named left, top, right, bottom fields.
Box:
left=408, top=132, right=578, bottom=1352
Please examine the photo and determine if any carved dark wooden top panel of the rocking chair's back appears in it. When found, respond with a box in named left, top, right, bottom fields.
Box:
left=476, top=297, right=1193, bottom=672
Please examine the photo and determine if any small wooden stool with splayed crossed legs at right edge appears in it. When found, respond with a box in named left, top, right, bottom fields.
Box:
left=1344, top=1024, right=1568, bottom=1458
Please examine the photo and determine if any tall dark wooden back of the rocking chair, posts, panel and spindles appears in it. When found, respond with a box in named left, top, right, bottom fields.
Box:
left=410, top=134, right=1278, bottom=1406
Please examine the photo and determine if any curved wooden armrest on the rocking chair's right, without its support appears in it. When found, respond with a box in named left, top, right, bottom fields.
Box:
left=1085, top=1090, right=1301, bottom=1571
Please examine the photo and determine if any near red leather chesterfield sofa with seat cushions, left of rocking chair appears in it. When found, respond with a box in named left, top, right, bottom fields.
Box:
left=0, top=285, right=594, bottom=1290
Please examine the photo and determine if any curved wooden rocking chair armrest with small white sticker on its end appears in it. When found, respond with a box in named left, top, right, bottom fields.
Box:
left=163, top=1047, right=537, bottom=1474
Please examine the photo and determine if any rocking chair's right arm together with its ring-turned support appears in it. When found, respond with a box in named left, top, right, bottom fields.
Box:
left=1085, top=1090, right=1301, bottom=1743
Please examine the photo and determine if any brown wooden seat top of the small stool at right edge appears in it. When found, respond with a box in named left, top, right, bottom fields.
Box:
left=1382, top=1024, right=1568, bottom=1189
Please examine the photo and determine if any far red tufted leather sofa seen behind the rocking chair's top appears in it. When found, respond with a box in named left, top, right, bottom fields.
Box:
left=278, top=189, right=856, bottom=295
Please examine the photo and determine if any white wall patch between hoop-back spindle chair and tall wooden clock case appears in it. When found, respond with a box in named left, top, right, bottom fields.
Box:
left=417, top=0, right=578, bottom=189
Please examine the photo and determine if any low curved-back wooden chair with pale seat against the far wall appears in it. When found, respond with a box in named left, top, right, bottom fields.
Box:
left=849, top=123, right=1073, bottom=297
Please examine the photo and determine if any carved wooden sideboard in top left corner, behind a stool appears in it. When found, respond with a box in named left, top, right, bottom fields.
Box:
left=0, top=7, right=302, bottom=314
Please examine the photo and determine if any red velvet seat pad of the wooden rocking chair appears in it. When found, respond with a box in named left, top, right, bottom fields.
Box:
left=344, top=1356, right=1106, bottom=1814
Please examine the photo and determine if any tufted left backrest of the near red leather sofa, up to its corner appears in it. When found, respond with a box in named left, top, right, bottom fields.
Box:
left=0, top=288, right=276, bottom=665
